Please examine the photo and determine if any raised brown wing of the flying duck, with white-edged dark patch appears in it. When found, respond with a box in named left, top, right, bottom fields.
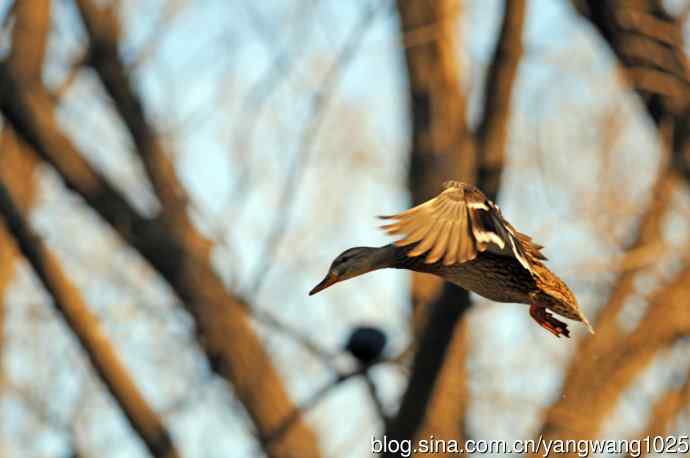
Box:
left=381, top=181, right=546, bottom=272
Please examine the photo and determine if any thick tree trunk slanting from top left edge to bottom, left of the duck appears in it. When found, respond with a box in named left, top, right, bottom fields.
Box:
left=68, top=0, right=319, bottom=456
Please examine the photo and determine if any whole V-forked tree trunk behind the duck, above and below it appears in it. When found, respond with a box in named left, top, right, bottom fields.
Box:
left=386, top=0, right=525, bottom=450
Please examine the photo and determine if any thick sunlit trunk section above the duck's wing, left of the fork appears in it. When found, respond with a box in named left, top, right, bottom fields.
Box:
left=397, top=0, right=475, bottom=203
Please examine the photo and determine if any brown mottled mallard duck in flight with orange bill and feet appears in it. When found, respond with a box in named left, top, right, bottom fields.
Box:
left=309, top=181, right=594, bottom=337
